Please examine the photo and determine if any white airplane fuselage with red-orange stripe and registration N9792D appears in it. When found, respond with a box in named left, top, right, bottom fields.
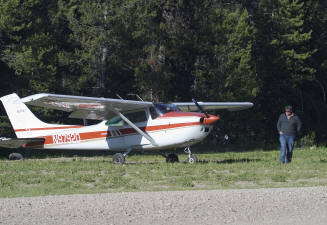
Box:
left=21, top=104, right=219, bottom=151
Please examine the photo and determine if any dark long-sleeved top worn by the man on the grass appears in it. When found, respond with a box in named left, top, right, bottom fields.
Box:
left=277, top=113, right=302, bottom=136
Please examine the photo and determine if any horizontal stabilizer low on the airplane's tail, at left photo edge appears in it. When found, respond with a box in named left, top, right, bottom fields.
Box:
left=0, top=137, right=45, bottom=148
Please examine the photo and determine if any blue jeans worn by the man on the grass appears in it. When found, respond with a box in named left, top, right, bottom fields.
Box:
left=279, top=134, right=295, bottom=163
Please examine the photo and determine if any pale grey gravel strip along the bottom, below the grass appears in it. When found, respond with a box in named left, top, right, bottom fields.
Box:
left=0, top=187, right=327, bottom=225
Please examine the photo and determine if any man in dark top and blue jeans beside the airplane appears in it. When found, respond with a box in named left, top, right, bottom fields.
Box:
left=277, top=105, right=302, bottom=163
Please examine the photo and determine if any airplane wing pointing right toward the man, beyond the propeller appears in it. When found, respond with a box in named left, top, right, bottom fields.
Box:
left=172, top=102, right=253, bottom=111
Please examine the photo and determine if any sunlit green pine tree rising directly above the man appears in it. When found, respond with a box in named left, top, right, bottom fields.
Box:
left=272, top=0, right=315, bottom=84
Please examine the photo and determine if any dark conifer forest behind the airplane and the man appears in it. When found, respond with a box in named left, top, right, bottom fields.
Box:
left=0, top=0, right=327, bottom=147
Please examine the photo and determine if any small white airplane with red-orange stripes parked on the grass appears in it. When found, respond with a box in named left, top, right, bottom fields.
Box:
left=0, top=93, right=253, bottom=164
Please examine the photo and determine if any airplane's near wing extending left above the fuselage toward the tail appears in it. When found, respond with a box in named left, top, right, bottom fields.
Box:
left=21, top=94, right=152, bottom=120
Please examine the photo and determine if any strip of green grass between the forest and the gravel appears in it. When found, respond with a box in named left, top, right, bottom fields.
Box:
left=0, top=148, right=327, bottom=197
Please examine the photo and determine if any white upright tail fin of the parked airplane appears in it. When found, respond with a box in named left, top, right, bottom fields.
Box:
left=0, top=93, right=50, bottom=138
